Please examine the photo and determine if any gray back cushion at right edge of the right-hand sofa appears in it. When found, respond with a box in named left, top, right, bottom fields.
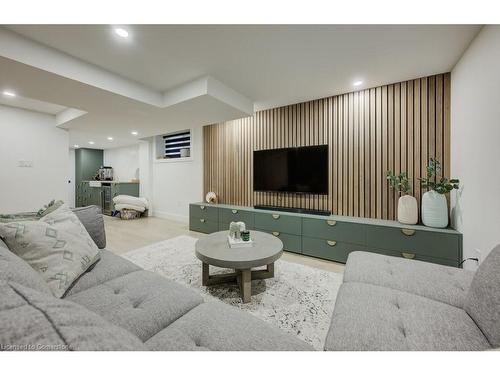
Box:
left=465, top=245, right=500, bottom=347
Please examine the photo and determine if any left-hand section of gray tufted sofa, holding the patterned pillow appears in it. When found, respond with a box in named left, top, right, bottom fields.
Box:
left=0, top=206, right=312, bottom=350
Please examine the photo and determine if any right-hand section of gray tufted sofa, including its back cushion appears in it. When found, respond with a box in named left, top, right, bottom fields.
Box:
left=325, top=245, right=500, bottom=350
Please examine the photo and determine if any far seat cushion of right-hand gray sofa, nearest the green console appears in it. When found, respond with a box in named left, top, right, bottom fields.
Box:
left=344, top=251, right=474, bottom=307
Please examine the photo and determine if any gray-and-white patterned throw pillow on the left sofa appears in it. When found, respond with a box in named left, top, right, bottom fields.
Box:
left=0, top=205, right=99, bottom=298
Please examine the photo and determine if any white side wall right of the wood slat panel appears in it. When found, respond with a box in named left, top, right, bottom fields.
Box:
left=451, top=26, right=500, bottom=268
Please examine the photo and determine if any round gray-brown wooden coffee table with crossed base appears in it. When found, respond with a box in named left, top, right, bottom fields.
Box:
left=195, top=231, right=283, bottom=303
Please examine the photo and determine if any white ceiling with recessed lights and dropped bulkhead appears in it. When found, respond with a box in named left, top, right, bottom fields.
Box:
left=0, top=25, right=480, bottom=147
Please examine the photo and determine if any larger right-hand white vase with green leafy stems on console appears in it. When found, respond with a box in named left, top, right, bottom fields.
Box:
left=420, top=159, right=460, bottom=228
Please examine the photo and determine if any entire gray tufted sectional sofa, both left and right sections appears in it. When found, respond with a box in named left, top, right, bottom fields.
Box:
left=0, top=206, right=500, bottom=350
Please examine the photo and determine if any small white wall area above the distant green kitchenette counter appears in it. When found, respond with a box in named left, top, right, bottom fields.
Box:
left=104, top=145, right=139, bottom=181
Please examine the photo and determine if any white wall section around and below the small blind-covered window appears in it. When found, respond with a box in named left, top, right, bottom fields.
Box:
left=147, top=127, right=203, bottom=222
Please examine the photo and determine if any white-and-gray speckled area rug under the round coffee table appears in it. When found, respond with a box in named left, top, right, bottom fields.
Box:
left=122, top=236, right=342, bottom=350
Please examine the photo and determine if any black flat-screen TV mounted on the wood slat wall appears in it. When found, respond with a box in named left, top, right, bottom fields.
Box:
left=253, top=145, right=328, bottom=194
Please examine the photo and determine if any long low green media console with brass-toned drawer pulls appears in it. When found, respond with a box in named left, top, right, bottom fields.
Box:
left=189, top=203, right=462, bottom=267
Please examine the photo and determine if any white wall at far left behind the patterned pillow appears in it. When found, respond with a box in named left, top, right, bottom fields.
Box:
left=0, top=105, right=69, bottom=213
